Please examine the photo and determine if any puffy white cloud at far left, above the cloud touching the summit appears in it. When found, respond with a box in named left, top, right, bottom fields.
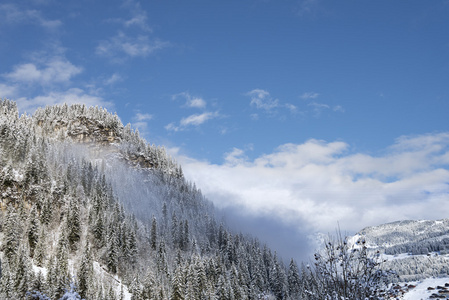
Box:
left=3, top=56, right=83, bottom=85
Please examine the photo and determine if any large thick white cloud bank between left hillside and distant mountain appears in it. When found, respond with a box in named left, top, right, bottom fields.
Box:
left=178, top=133, right=449, bottom=233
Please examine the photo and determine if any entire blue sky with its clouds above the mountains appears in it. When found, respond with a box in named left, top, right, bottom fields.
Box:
left=0, top=0, right=449, bottom=258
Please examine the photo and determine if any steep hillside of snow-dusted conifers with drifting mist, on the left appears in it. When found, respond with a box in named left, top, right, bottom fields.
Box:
left=0, top=100, right=308, bottom=299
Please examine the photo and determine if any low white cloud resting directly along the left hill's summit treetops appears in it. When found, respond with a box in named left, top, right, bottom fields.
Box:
left=16, top=88, right=112, bottom=113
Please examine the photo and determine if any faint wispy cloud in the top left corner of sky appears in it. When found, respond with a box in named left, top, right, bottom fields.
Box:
left=0, top=4, right=62, bottom=29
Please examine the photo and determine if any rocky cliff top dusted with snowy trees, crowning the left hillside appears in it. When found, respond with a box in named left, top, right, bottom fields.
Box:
left=33, top=105, right=183, bottom=177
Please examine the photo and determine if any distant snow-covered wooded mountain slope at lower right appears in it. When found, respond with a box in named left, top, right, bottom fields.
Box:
left=350, top=219, right=449, bottom=281
